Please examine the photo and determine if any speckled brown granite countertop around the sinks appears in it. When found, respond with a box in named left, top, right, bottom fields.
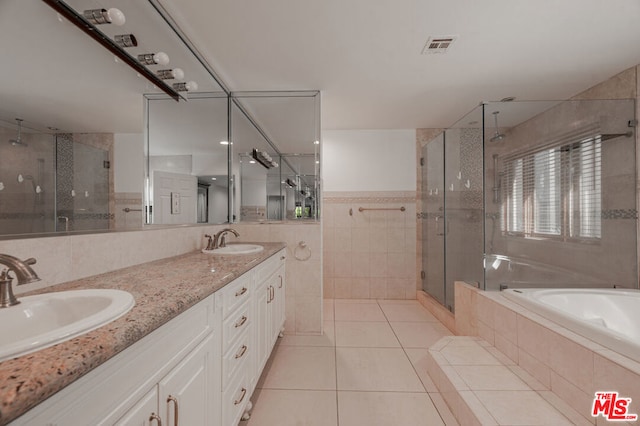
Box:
left=0, top=243, right=285, bottom=425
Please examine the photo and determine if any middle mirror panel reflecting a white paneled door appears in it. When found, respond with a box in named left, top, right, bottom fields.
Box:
left=147, top=93, right=229, bottom=224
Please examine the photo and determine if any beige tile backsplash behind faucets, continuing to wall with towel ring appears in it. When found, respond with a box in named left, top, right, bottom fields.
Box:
left=0, top=223, right=322, bottom=334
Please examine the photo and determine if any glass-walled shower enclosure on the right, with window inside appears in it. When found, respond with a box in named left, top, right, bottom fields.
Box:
left=421, top=99, right=638, bottom=310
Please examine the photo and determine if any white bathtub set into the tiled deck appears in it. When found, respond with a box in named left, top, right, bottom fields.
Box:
left=502, top=288, right=640, bottom=362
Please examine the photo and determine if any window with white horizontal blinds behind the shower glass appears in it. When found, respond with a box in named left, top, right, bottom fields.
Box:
left=501, top=136, right=602, bottom=240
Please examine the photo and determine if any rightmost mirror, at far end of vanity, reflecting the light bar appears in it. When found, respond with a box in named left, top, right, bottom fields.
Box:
left=231, top=91, right=320, bottom=221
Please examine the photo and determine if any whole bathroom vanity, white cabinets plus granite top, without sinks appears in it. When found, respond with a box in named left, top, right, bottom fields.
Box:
left=0, top=243, right=285, bottom=426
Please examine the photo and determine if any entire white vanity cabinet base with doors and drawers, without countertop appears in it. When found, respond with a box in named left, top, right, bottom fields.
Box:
left=11, top=249, right=285, bottom=426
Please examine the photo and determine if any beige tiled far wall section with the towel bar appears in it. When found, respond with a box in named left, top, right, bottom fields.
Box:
left=322, top=191, right=416, bottom=299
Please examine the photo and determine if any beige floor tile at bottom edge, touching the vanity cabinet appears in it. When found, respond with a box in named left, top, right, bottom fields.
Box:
left=240, top=389, right=338, bottom=426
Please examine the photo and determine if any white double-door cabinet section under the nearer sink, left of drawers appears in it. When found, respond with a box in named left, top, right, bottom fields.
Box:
left=12, top=294, right=221, bottom=426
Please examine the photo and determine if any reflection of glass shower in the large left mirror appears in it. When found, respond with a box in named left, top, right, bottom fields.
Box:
left=0, top=122, right=111, bottom=235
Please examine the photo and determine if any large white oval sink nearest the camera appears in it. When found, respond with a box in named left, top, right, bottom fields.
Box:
left=0, top=289, right=135, bottom=361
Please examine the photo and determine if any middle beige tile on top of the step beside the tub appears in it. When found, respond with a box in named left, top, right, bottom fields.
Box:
left=453, top=365, right=530, bottom=391
